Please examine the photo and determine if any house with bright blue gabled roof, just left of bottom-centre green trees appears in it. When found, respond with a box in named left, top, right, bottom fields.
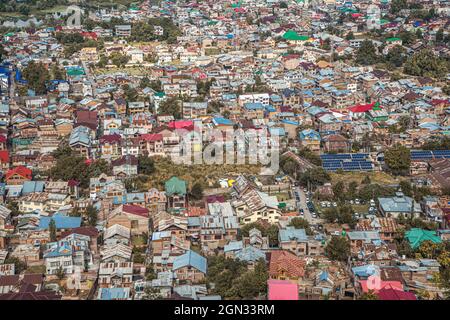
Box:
left=172, top=250, right=207, bottom=283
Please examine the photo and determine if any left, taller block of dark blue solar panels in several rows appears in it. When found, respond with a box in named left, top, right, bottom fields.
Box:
left=320, top=153, right=373, bottom=171
